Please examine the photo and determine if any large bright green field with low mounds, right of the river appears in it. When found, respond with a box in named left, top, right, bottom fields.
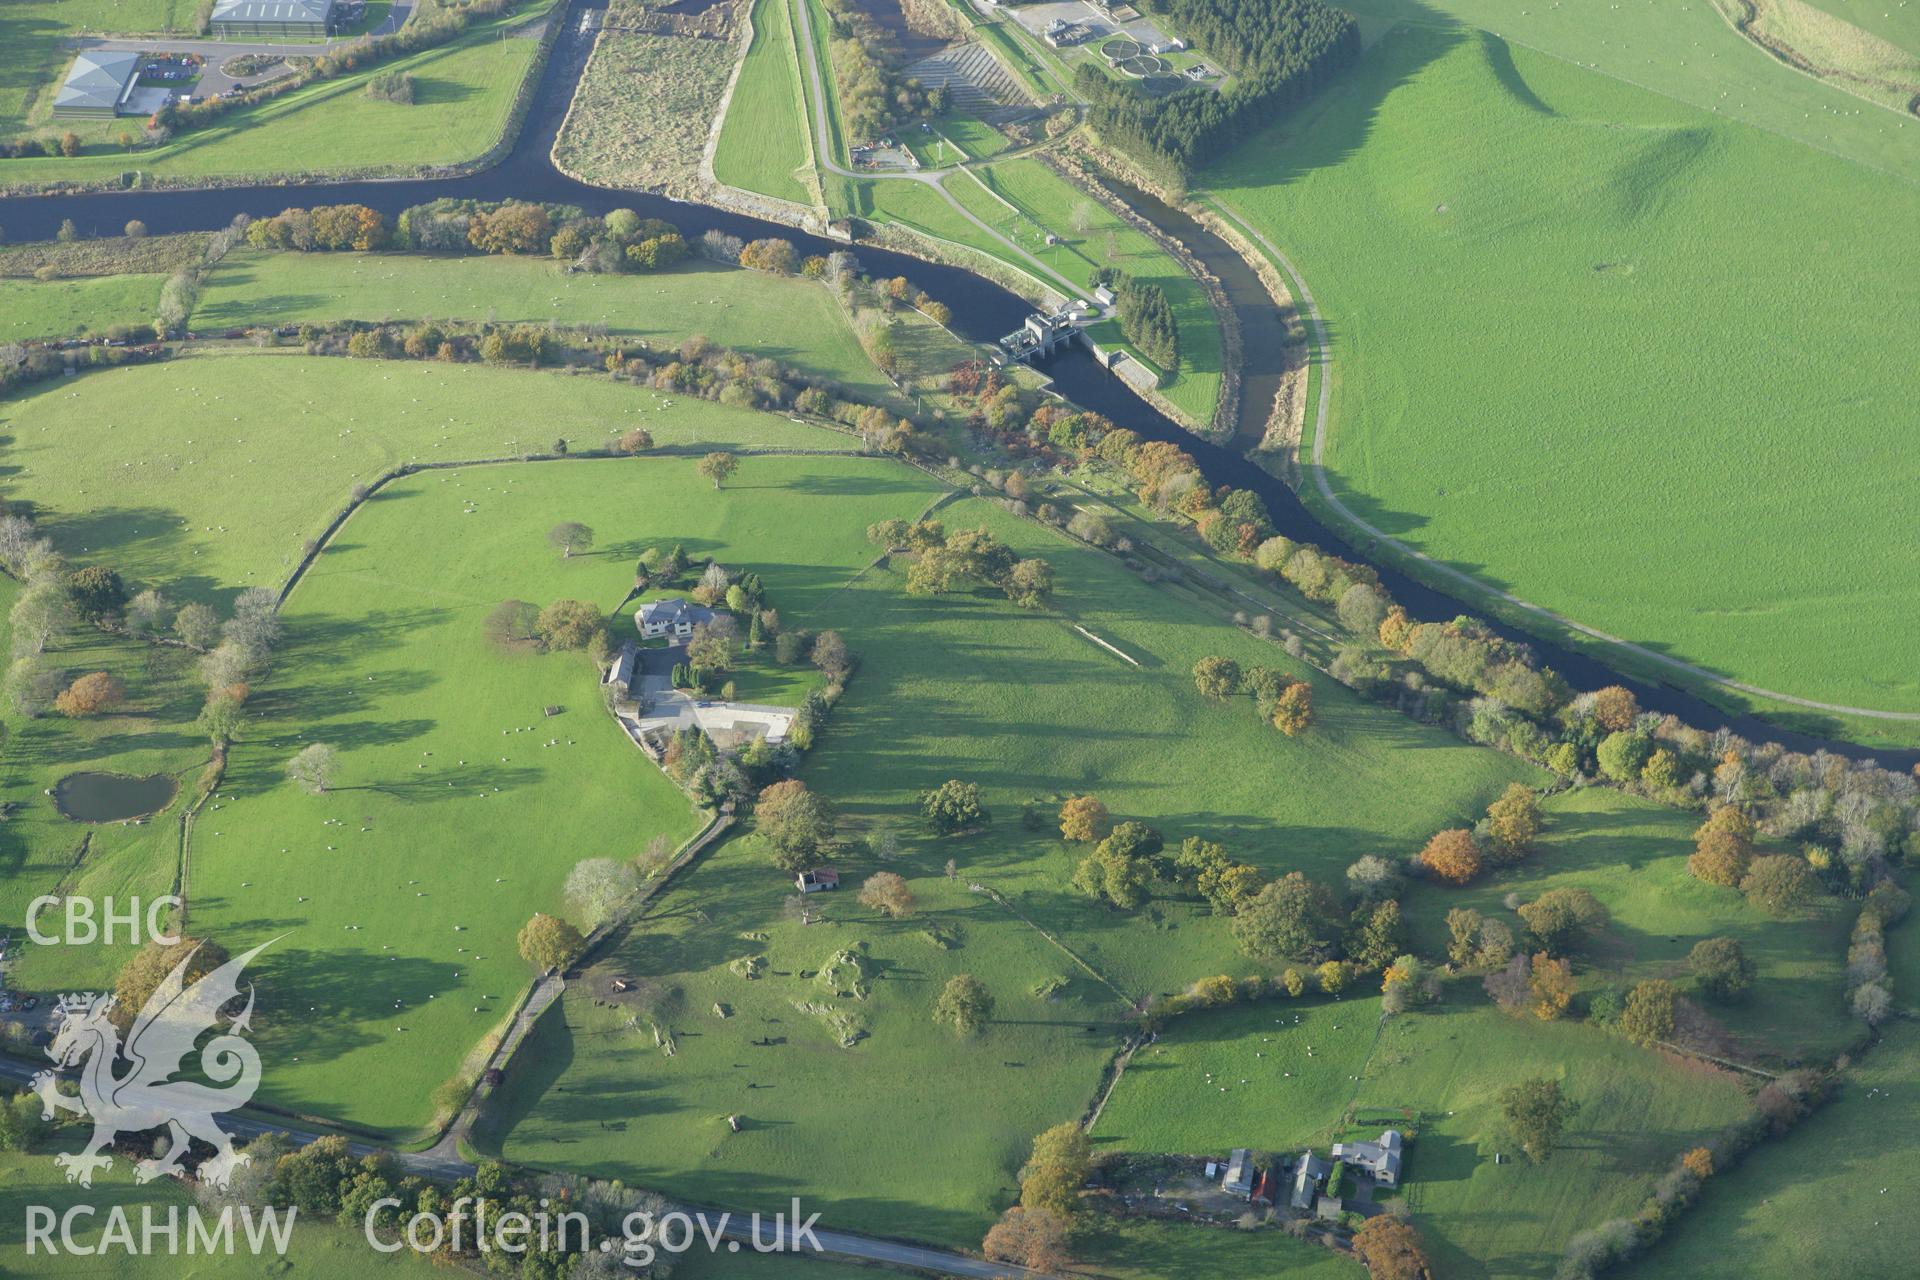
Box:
left=1208, top=25, right=1920, bottom=710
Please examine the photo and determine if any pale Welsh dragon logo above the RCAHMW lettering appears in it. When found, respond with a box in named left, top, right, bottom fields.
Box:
left=33, top=942, right=271, bottom=1188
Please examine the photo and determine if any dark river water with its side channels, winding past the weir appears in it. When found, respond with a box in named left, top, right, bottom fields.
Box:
left=0, top=0, right=1920, bottom=770
